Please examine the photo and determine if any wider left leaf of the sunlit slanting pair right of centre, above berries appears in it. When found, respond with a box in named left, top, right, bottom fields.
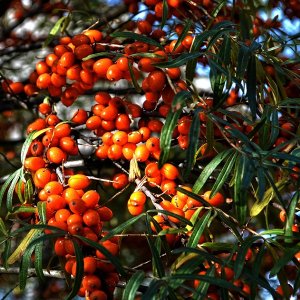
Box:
left=193, top=149, right=234, bottom=194
